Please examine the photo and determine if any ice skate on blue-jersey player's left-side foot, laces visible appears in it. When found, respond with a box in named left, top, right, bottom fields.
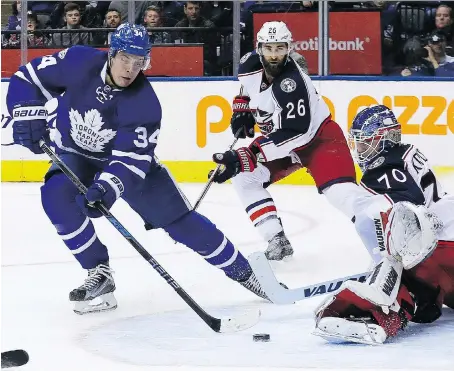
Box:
left=69, top=263, right=117, bottom=314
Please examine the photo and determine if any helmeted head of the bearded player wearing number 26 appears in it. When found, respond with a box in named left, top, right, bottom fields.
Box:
left=256, top=22, right=293, bottom=77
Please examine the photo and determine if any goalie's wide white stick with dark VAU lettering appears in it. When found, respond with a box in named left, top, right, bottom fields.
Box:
left=248, top=252, right=370, bottom=304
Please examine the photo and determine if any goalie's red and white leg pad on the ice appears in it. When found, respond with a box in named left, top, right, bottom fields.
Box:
left=315, top=257, right=414, bottom=343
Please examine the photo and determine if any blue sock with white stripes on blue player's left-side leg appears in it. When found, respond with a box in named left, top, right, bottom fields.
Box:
left=41, top=173, right=109, bottom=269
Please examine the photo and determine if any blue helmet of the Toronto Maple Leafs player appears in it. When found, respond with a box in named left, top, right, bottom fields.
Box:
left=109, top=23, right=151, bottom=70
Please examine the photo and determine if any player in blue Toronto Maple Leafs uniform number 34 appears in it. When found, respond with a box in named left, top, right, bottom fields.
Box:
left=7, top=23, right=266, bottom=314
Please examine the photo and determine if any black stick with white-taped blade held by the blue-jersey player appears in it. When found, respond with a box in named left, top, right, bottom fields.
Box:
left=39, top=140, right=260, bottom=333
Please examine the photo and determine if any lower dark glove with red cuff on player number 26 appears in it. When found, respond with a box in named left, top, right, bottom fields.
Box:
left=209, top=147, right=257, bottom=183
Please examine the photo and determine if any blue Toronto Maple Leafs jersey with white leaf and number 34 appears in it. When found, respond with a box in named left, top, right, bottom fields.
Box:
left=7, top=46, right=162, bottom=192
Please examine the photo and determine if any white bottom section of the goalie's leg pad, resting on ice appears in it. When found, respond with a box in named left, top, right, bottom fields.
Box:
left=313, top=316, right=388, bottom=345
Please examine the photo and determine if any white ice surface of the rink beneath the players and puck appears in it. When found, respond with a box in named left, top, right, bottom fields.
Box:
left=1, top=177, right=454, bottom=371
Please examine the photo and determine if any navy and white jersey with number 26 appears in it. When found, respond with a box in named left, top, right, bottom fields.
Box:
left=238, top=52, right=330, bottom=161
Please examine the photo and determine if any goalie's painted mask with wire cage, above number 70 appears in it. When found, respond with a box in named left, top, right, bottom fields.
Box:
left=348, top=105, right=401, bottom=171
